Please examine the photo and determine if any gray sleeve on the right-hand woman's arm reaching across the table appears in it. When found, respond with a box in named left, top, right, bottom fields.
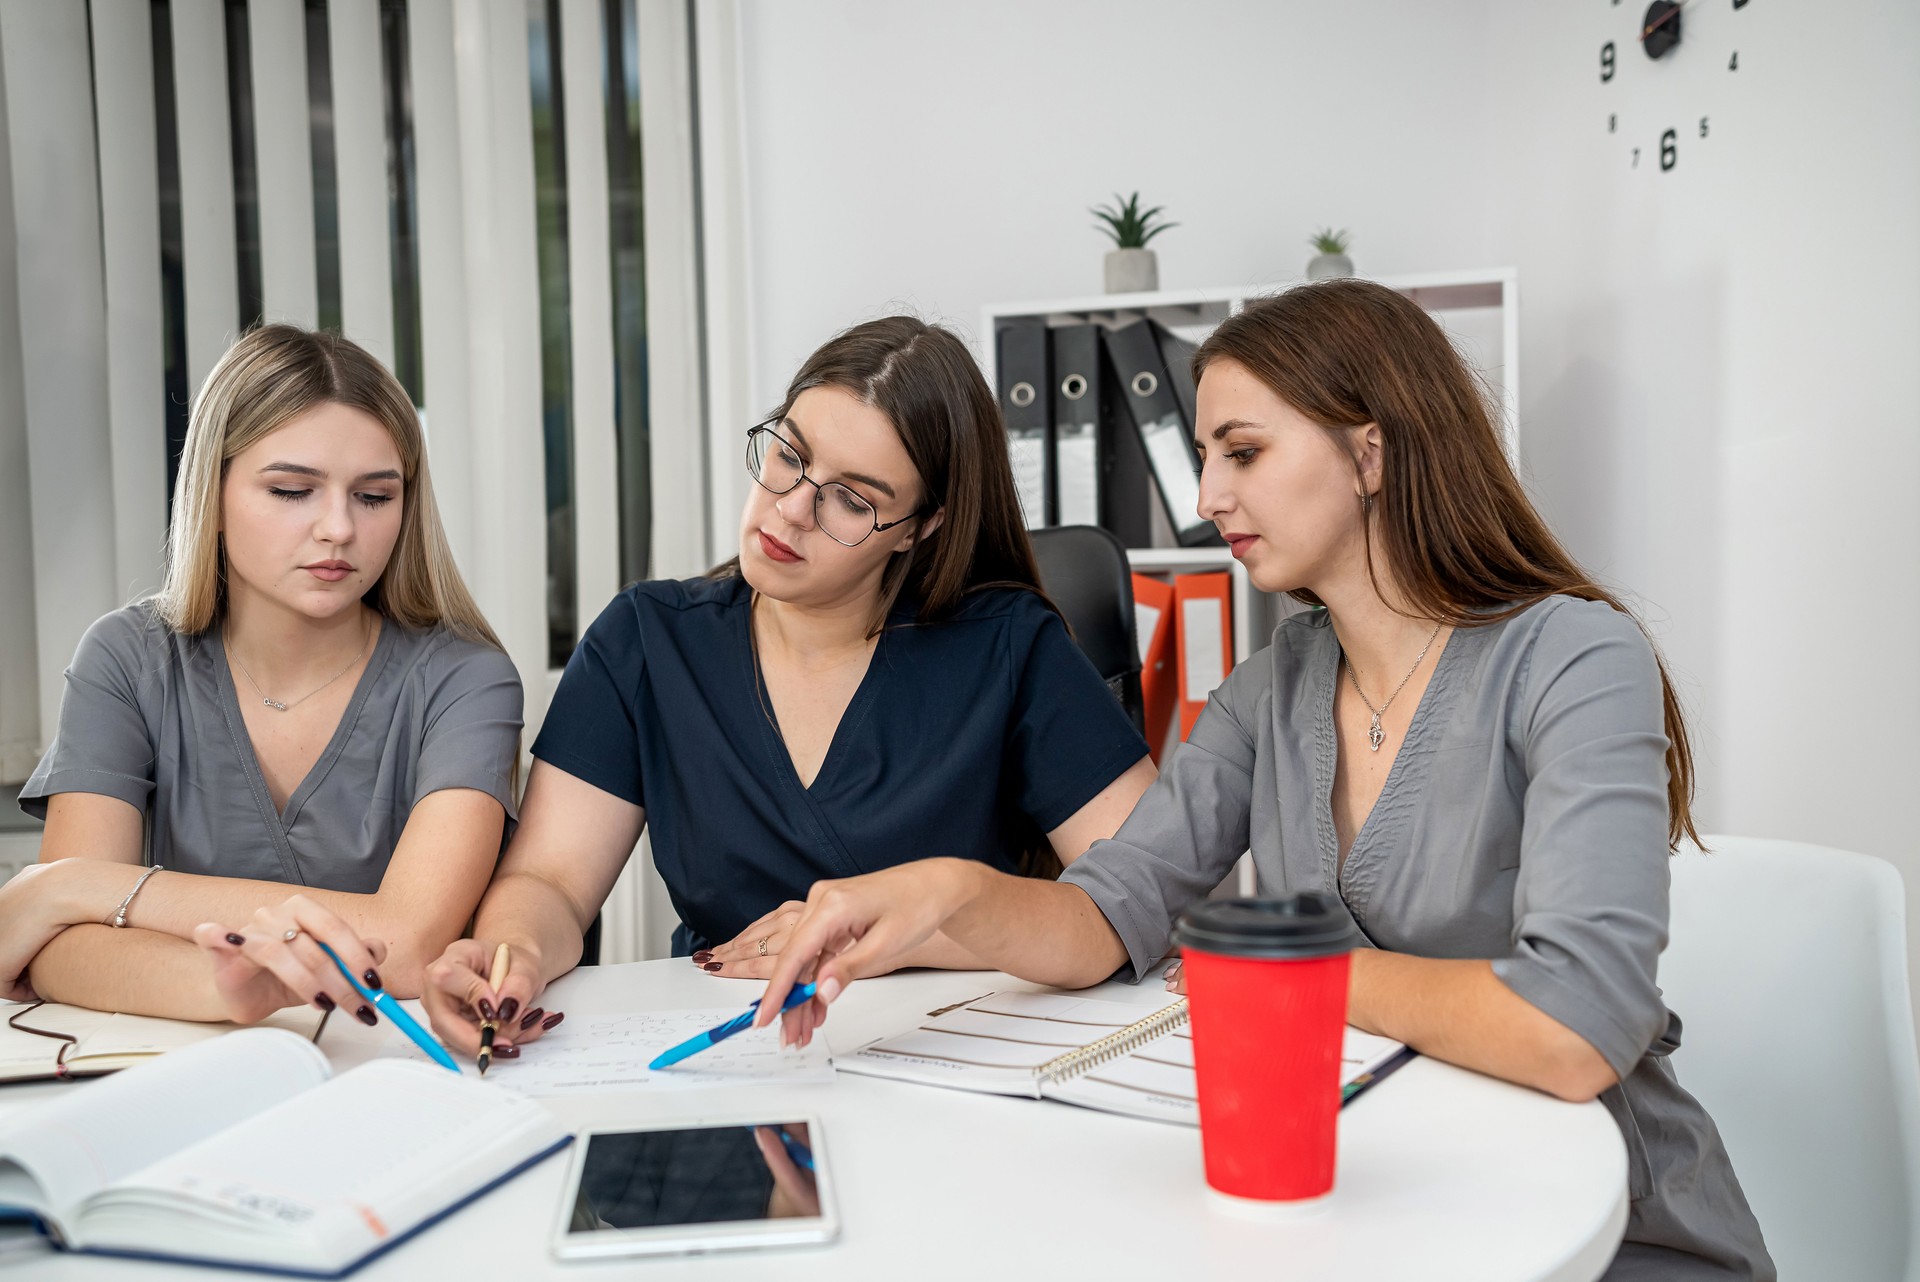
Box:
left=1060, top=662, right=1271, bottom=979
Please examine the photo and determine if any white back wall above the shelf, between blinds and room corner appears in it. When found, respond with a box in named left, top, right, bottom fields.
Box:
left=716, top=0, right=1492, bottom=529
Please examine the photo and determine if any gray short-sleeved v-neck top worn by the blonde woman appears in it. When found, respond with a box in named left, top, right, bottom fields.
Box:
left=19, top=601, right=520, bottom=894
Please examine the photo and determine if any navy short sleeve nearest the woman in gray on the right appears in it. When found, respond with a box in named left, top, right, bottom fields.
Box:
left=1006, top=606, right=1146, bottom=833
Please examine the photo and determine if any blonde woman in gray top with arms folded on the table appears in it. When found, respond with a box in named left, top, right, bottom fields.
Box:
left=0, top=324, right=520, bottom=1023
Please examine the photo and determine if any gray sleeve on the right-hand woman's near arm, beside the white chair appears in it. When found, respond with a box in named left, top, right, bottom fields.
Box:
left=1494, top=601, right=1668, bottom=1079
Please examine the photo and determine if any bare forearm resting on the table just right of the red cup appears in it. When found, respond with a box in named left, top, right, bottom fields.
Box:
left=1346, top=948, right=1619, bottom=1100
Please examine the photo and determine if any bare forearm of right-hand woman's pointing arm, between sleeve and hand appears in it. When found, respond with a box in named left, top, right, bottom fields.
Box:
left=924, top=860, right=1127, bottom=988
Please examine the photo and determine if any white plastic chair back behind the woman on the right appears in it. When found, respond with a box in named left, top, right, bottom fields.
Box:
left=1659, top=837, right=1920, bottom=1282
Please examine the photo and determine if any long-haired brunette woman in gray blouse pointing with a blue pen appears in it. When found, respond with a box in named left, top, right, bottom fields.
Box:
left=760, top=280, right=1774, bottom=1278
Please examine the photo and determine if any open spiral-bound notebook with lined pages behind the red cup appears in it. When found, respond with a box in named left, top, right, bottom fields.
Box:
left=833, top=992, right=1413, bottom=1127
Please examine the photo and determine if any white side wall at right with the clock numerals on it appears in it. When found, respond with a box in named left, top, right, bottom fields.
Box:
left=1488, top=0, right=1920, bottom=975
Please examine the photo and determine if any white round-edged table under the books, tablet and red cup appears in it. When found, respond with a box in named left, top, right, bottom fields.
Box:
left=11, top=960, right=1626, bottom=1282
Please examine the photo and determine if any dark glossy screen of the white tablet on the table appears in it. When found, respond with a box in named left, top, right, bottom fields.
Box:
left=566, top=1121, right=820, bottom=1240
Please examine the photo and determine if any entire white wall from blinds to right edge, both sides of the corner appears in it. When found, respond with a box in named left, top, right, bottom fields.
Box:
left=716, top=0, right=1920, bottom=990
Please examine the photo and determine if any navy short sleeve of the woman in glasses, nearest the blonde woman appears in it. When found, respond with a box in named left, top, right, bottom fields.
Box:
left=534, top=593, right=647, bottom=806
